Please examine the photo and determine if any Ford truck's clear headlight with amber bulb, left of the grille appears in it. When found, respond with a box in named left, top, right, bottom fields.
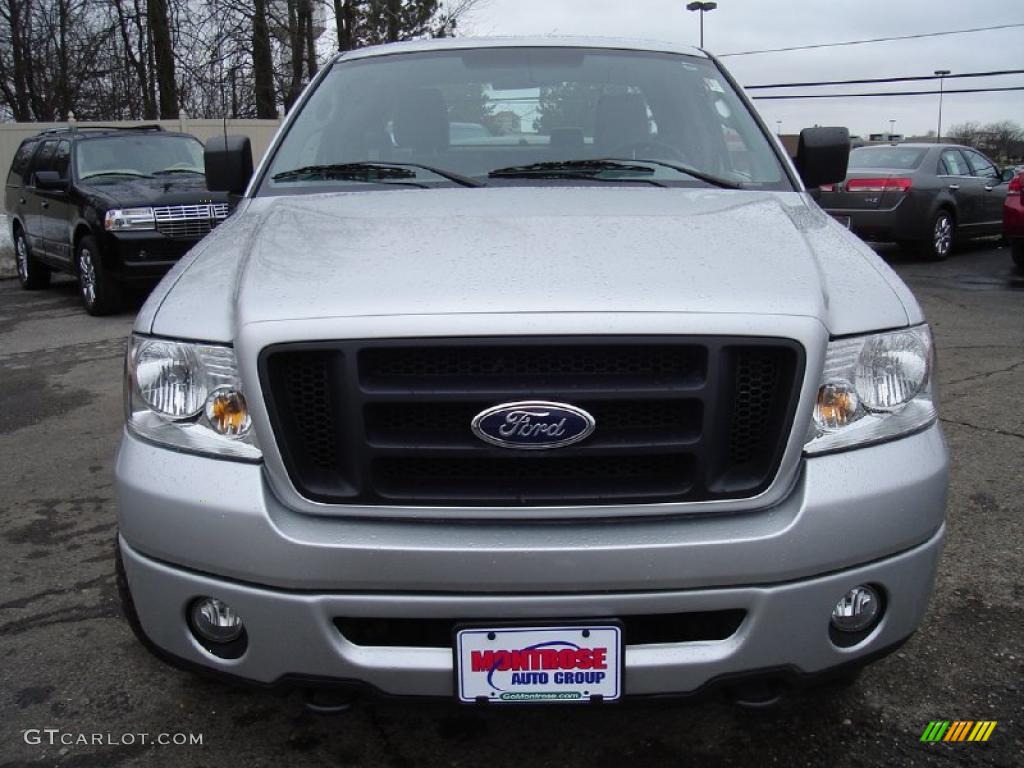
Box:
left=125, top=335, right=262, bottom=460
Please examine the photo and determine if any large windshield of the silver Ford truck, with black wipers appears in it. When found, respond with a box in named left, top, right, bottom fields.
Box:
left=261, top=48, right=793, bottom=195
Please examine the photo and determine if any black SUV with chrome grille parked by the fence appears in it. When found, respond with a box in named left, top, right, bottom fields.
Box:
left=4, top=126, right=228, bottom=314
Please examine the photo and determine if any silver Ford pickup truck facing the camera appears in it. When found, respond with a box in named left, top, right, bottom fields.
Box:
left=116, top=37, right=947, bottom=707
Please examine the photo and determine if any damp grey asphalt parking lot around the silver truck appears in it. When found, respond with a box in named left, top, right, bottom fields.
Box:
left=0, top=244, right=1024, bottom=768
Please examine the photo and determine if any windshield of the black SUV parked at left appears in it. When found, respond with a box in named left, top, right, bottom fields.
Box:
left=75, top=133, right=204, bottom=179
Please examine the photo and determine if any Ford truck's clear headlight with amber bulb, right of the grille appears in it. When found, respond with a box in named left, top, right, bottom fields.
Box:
left=804, top=326, right=936, bottom=454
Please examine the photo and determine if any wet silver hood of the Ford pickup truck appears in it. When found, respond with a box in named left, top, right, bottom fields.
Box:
left=142, top=186, right=920, bottom=341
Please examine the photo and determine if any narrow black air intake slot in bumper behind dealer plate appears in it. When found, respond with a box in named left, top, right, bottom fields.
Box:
left=334, top=608, right=746, bottom=648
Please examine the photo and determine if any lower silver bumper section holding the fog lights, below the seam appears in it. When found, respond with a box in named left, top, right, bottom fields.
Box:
left=120, top=527, right=945, bottom=696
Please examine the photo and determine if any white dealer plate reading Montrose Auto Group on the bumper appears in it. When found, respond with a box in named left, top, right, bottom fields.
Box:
left=455, top=625, right=623, bottom=703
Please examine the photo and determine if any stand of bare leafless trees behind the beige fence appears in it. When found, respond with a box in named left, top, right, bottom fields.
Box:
left=0, top=0, right=479, bottom=121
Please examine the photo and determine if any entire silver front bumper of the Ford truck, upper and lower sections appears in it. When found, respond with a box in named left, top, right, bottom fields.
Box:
left=116, top=426, right=947, bottom=696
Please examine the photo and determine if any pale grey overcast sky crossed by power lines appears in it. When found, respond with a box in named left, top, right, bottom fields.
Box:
left=461, top=0, right=1024, bottom=135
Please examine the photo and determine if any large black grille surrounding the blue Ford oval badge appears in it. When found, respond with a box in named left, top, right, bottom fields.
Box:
left=260, top=337, right=803, bottom=506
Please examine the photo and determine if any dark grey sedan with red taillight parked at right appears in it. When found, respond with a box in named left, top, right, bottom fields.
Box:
left=818, top=143, right=1009, bottom=260
